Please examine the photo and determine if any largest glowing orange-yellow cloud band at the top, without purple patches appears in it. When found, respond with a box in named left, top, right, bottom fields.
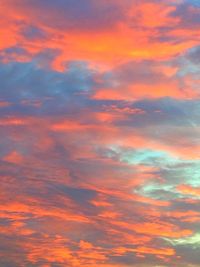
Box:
left=0, top=1, right=198, bottom=70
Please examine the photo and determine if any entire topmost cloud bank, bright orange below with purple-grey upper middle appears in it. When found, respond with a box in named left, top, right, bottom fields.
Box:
left=0, top=0, right=198, bottom=70
